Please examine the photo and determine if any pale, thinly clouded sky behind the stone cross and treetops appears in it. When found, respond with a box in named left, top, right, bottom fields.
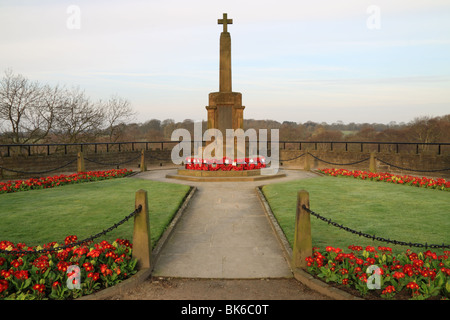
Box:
left=0, top=0, right=450, bottom=123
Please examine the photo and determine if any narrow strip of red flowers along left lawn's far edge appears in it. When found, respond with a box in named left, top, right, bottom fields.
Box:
left=0, top=169, right=132, bottom=194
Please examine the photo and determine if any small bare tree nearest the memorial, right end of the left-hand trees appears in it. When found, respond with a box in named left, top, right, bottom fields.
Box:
left=99, top=95, right=136, bottom=142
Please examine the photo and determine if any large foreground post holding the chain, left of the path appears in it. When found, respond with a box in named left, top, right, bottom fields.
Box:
left=132, top=190, right=152, bottom=270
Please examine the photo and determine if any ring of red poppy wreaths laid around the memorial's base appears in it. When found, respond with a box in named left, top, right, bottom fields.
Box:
left=185, top=157, right=266, bottom=171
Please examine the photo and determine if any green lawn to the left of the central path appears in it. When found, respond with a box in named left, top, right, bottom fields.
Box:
left=0, top=178, right=189, bottom=249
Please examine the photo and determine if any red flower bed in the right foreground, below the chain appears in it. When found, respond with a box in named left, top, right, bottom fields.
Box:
left=306, top=245, right=450, bottom=300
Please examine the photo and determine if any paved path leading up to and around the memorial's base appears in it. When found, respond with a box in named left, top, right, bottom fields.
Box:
left=132, top=170, right=316, bottom=279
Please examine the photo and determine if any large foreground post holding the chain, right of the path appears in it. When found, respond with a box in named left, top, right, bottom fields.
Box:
left=292, top=190, right=312, bottom=269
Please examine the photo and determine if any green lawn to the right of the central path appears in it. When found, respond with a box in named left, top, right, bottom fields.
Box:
left=262, top=177, right=450, bottom=252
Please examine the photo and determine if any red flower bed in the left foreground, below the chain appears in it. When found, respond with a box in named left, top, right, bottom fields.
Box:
left=0, top=236, right=137, bottom=300
